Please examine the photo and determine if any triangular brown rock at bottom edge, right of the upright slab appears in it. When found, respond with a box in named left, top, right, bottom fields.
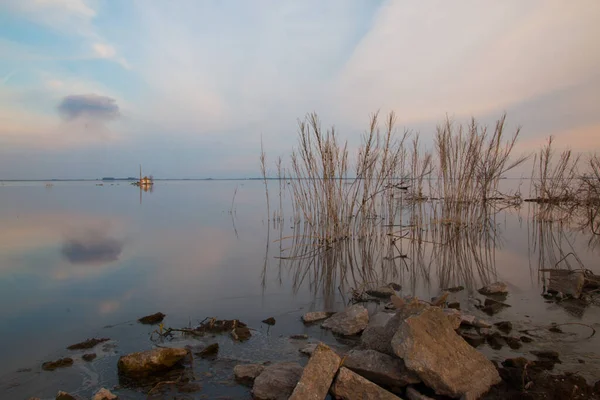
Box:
left=331, top=367, right=400, bottom=400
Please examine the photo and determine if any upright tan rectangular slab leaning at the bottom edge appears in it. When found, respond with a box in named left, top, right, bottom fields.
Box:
left=290, top=343, right=341, bottom=400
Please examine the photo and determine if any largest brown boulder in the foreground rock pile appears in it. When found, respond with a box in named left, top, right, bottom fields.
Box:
left=391, top=307, right=500, bottom=400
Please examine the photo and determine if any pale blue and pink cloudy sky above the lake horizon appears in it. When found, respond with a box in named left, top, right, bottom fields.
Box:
left=0, top=0, right=600, bottom=179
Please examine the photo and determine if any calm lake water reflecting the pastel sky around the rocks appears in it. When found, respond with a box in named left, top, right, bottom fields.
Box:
left=0, top=181, right=600, bottom=399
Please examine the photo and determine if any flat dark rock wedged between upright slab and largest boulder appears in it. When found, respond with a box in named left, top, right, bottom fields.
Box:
left=344, top=350, right=421, bottom=388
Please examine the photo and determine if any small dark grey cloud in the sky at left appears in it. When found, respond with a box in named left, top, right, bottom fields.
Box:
left=58, top=94, right=121, bottom=121
